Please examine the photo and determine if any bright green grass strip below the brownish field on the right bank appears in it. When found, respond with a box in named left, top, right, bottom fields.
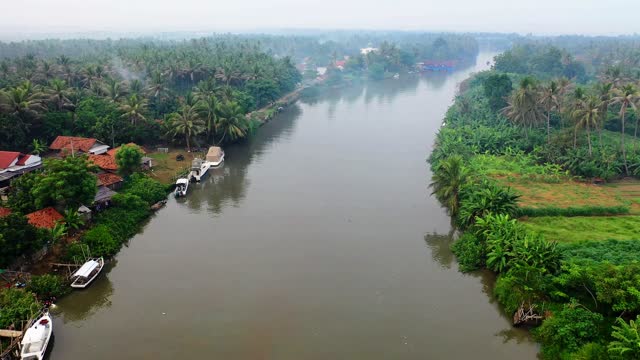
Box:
left=523, top=216, right=640, bottom=242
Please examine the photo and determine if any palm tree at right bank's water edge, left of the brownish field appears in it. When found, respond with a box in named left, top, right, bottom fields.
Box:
left=429, top=155, right=469, bottom=219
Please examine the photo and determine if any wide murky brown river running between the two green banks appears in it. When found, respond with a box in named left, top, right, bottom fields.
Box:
left=50, top=53, right=537, bottom=360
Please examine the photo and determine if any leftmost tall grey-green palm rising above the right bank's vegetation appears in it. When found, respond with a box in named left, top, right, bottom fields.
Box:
left=502, top=77, right=543, bottom=137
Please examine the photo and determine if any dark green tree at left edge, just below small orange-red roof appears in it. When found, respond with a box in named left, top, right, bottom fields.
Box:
left=0, top=213, right=44, bottom=268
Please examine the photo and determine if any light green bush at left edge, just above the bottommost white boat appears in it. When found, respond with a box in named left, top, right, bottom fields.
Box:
left=0, top=288, right=40, bottom=329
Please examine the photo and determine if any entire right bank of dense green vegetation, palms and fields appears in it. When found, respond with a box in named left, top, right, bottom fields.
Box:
left=429, top=38, right=640, bottom=359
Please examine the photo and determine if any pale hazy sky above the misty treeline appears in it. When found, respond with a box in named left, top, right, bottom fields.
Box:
left=0, top=0, right=640, bottom=35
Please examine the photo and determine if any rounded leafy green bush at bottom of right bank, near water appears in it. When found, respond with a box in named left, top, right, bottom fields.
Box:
left=534, top=304, right=604, bottom=359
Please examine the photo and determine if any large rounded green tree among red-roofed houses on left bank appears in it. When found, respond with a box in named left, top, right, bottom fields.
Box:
left=31, top=156, right=97, bottom=209
